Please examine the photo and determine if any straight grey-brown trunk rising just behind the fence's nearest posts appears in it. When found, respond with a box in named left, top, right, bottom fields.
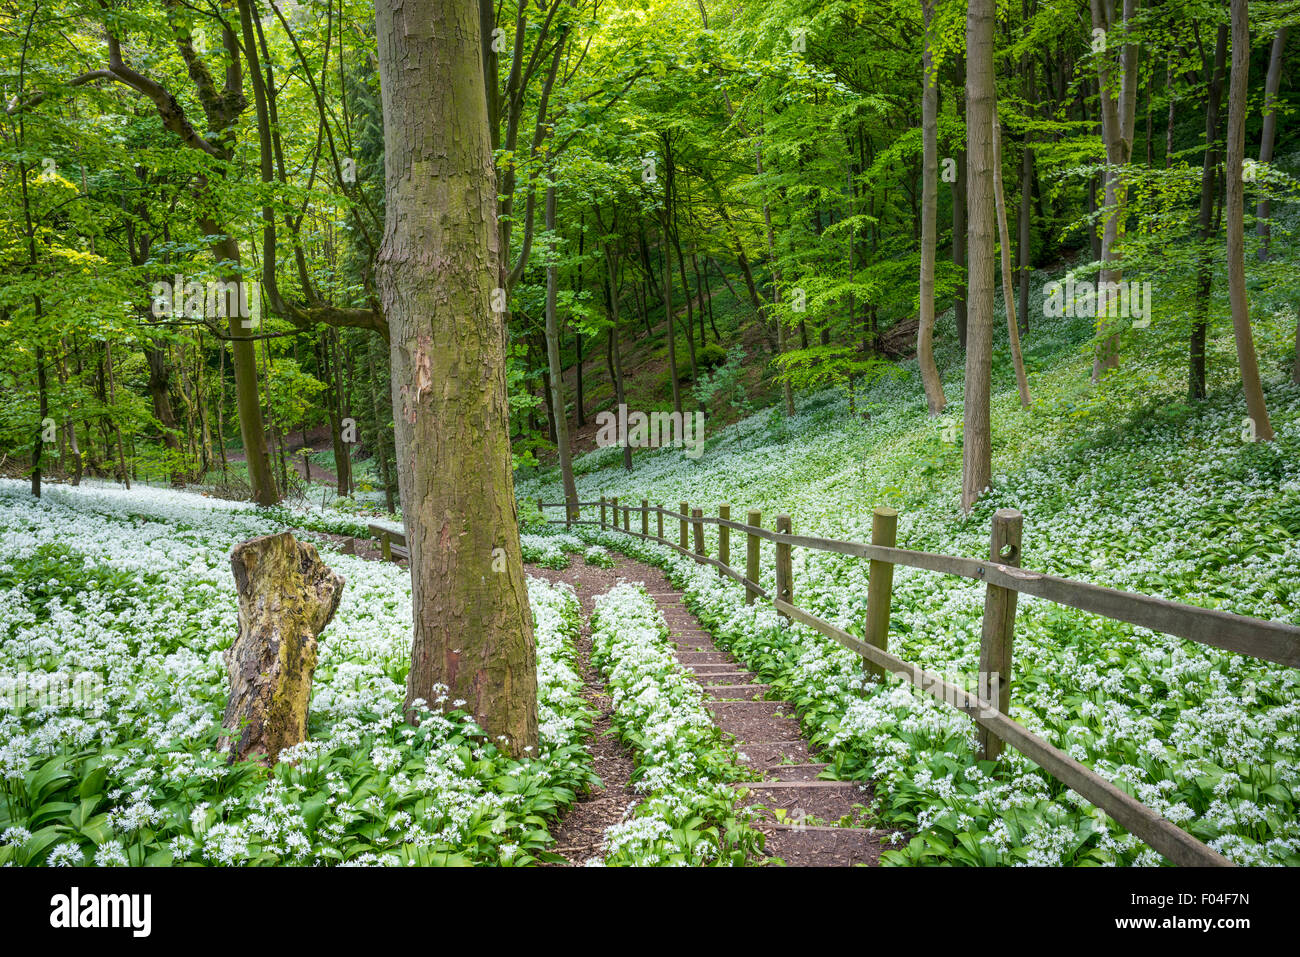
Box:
left=962, top=0, right=996, bottom=511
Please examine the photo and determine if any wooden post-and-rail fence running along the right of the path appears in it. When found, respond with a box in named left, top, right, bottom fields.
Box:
left=537, top=497, right=1300, bottom=866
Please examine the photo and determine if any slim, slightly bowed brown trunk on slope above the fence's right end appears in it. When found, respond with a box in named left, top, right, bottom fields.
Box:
left=1223, top=0, right=1273, bottom=442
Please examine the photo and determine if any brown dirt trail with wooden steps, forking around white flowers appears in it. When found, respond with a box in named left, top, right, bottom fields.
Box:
left=527, top=553, right=884, bottom=867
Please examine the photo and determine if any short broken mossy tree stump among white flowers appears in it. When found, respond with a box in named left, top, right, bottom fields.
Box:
left=218, top=532, right=343, bottom=766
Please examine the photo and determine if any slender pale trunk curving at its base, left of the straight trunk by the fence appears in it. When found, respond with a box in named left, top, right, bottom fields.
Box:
left=917, top=0, right=948, bottom=415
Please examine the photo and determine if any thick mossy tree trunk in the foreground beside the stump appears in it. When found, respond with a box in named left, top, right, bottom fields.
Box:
left=374, top=0, right=537, bottom=755
